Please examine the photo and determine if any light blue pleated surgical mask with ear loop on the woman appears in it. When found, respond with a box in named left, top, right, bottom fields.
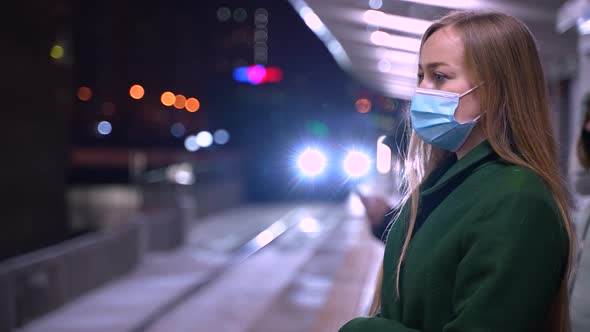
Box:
left=410, top=84, right=481, bottom=152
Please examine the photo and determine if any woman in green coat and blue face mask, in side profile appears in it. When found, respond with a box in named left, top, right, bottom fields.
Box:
left=340, top=12, right=574, bottom=332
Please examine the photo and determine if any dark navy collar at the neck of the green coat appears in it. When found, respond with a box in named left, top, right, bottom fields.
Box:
left=420, top=140, right=497, bottom=195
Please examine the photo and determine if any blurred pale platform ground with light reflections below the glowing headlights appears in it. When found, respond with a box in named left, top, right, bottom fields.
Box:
left=17, top=202, right=383, bottom=332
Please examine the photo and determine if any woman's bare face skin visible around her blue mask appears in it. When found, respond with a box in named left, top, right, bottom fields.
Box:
left=418, top=27, right=481, bottom=123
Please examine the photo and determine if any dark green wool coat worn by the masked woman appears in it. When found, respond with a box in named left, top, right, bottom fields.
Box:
left=340, top=141, right=569, bottom=332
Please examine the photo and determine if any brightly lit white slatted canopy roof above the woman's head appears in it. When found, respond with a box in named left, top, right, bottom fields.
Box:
left=289, top=0, right=590, bottom=99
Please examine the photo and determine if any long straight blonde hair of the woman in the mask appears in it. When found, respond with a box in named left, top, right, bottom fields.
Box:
left=371, top=11, right=575, bottom=332
